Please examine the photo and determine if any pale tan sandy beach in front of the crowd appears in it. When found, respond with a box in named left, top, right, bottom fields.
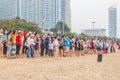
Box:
left=0, top=53, right=120, bottom=80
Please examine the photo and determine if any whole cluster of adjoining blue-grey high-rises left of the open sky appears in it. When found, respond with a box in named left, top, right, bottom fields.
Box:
left=0, top=0, right=71, bottom=29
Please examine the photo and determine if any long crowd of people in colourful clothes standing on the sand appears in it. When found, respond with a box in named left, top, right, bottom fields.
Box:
left=0, top=28, right=118, bottom=59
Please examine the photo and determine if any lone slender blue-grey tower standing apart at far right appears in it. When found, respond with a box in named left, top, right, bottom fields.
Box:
left=109, top=6, right=117, bottom=38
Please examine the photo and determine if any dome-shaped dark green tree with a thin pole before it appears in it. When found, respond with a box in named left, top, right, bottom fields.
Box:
left=51, top=21, right=71, bottom=34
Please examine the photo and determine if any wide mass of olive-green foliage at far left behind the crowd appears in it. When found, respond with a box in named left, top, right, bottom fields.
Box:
left=0, top=17, right=42, bottom=33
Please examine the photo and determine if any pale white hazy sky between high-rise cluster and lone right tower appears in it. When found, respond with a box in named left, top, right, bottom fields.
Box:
left=71, top=0, right=118, bottom=32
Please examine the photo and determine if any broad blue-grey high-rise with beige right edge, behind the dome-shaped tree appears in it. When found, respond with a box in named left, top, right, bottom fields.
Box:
left=39, top=0, right=71, bottom=29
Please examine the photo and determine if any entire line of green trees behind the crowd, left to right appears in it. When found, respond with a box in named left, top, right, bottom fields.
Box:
left=0, top=17, right=120, bottom=43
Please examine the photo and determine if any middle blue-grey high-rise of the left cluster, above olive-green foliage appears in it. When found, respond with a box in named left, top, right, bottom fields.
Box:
left=19, top=0, right=39, bottom=23
